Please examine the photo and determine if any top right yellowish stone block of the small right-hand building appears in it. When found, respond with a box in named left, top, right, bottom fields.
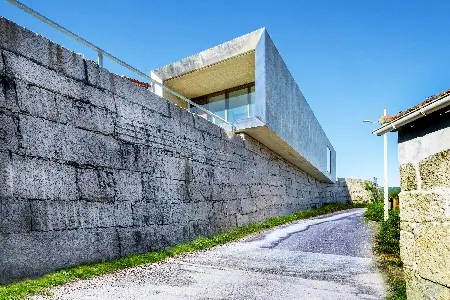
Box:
left=419, top=149, right=450, bottom=190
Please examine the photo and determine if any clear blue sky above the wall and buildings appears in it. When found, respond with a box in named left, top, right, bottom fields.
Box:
left=0, top=0, right=450, bottom=185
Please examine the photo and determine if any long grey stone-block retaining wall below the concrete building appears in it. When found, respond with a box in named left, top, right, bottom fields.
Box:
left=0, top=18, right=346, bottom=283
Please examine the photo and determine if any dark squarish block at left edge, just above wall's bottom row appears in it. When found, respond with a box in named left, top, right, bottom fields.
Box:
left=0, top=198, right=31, bottom=234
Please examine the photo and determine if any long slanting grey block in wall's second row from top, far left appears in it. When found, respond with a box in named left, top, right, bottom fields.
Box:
left=3, top=51, right=83, bottom=99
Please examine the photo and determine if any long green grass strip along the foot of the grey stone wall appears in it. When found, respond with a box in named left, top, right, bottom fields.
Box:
left=0, top=204, right=362, bottom=300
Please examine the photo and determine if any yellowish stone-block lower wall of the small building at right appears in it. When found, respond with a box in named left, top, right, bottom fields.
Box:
left=400, top=150, right=450, bottom=300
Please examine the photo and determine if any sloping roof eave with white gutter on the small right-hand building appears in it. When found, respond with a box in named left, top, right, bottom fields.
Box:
left=372, top=96, right=450, bottom=136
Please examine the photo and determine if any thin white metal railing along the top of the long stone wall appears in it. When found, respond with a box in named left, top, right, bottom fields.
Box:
left=7, top=0, right=235, bottom=130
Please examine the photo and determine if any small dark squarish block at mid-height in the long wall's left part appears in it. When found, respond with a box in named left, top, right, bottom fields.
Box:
left=77, top=169, right=116, bottom=203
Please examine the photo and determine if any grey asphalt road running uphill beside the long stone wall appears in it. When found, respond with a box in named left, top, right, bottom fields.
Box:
left=36, top=209, right=385, bottom=300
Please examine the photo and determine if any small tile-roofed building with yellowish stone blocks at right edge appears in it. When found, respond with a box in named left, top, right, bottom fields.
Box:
left=374, top=90, right=450, bottom=299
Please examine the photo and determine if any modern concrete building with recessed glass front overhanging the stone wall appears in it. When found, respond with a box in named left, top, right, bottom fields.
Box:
left=152, top=28, right=336, bottom=183
